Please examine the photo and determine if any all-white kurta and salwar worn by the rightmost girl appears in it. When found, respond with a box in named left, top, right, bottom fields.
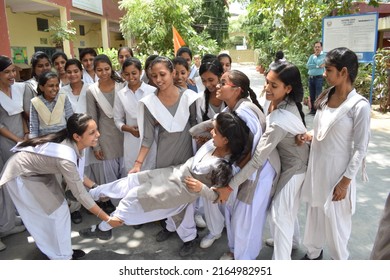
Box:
left=302, top=89, right=370, bottom=260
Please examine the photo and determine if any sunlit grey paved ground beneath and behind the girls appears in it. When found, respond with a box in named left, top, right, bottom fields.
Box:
left=0, top=64, right=390, bottom=264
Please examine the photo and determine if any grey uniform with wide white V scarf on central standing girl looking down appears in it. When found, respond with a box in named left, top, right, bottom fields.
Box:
left=138, top=89, right=198, bottom=242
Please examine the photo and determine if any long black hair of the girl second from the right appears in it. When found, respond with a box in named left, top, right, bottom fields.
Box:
left=270, top=62, right=306, bottom=126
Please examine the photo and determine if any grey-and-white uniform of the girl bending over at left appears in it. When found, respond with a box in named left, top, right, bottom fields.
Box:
left=0, top=140, right=95, bottom=260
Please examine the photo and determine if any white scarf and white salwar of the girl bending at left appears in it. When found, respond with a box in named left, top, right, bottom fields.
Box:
left=5, top=143, right=84, bottom=260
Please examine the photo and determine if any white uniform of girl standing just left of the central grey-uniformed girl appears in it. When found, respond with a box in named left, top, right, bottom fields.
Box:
left=114, top=83, right=156, bottom=171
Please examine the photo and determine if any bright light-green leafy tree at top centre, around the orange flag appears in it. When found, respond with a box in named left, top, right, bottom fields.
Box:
left=119, top=0, right=218, bottom=56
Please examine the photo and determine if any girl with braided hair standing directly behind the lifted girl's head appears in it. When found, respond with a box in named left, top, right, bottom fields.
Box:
left=213, top=70, right=280, bottom=260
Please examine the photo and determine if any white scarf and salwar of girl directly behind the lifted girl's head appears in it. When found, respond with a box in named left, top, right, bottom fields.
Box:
left=225, top=102, right=276, bottom=260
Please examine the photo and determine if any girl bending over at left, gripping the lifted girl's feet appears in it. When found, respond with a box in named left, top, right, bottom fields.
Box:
left=0, top=114, right=120, bottom=260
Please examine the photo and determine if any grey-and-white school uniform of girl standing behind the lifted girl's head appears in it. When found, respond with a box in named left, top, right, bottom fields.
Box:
left=225, top=99, right=280, bottom=260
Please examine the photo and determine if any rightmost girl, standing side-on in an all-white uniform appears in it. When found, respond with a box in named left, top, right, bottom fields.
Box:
left=298, top=48, right=371, bottom=260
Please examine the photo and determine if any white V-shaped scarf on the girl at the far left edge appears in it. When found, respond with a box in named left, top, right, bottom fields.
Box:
left=0, top=83, right=26, bottom=116
